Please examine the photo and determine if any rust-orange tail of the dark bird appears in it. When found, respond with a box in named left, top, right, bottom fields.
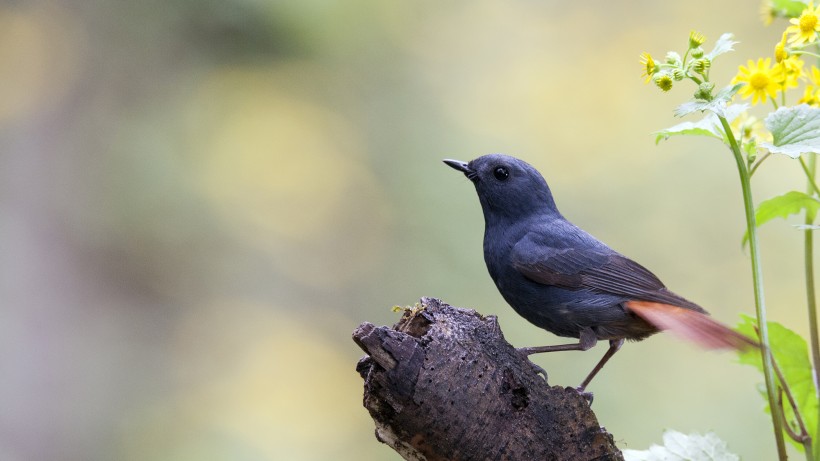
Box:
left=626, top=301, right=760, bottom=350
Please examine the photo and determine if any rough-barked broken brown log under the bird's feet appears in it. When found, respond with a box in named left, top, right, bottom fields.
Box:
left=353, top=298, right=623, bottom=461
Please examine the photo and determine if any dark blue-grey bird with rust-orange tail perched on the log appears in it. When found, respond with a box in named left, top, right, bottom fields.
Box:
left=444, top=154, right=757, bottom=392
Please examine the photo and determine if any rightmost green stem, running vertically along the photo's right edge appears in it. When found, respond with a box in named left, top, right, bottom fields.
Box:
left=800, top=155, right=820, bottom=458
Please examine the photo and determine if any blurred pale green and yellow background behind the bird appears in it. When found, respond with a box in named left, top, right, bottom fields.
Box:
left=0, top=0, right=807, bottom=461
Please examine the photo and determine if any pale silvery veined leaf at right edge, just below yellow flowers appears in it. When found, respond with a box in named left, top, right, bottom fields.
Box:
left=760, top=104, right=820, bottom=158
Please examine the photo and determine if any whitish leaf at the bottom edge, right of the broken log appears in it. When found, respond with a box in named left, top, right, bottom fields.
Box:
left=623, top=430, right=740, bottom=461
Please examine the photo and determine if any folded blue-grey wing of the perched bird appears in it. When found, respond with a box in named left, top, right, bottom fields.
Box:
left=511, top=233, right=702, bottom=311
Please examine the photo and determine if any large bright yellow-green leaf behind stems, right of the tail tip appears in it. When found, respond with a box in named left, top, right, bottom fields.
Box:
left=736, top=315, right=818, bottom=451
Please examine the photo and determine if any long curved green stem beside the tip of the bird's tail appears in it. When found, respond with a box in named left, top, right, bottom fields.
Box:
left=718, top=115, right=787, bottom=461
